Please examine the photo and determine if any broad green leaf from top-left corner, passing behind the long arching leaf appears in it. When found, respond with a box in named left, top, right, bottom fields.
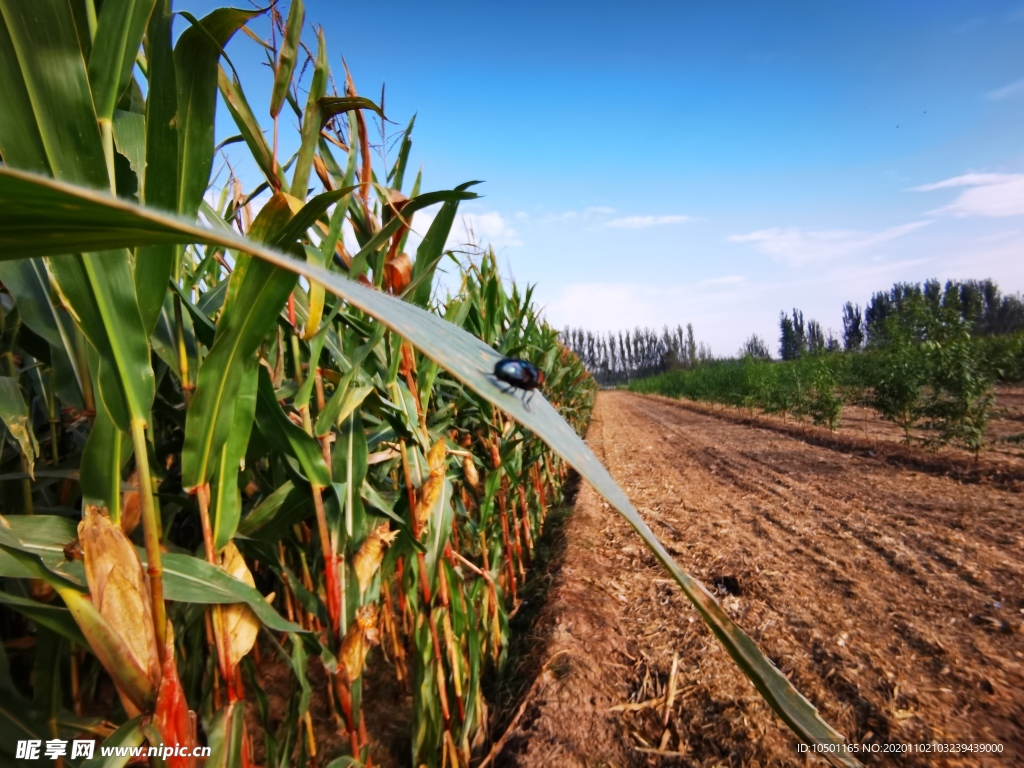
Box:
left=0, top=0, right=155, bottom=430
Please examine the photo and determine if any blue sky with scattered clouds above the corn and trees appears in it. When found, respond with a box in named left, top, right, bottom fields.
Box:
left=182, top=0, right=1024, bottom=354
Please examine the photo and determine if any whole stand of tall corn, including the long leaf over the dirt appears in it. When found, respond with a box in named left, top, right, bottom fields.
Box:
left=0, top=0, right=852, bottom=768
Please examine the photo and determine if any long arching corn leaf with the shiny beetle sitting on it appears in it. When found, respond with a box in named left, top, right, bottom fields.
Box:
left=0, top=168, right=857, bottom=765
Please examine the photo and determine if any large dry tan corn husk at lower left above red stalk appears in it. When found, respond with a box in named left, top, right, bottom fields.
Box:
left=78, top=505, right=161, bottom=717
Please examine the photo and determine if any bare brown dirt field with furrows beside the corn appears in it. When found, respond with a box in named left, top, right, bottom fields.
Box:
left=495, top=392, right=1024, bottom=766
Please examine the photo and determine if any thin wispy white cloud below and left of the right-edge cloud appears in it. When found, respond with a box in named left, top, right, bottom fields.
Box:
left=729, top=221, right=931, bottom=265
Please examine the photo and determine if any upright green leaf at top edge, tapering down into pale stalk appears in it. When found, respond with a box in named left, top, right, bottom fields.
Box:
left=89, top=0, right=155, bottom=121
